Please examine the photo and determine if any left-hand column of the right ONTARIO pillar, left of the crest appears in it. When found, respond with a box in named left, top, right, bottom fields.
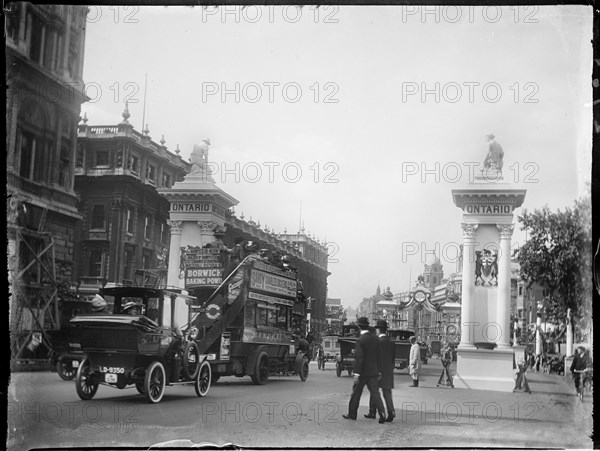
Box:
left=460, top=222, right=477, bottom=349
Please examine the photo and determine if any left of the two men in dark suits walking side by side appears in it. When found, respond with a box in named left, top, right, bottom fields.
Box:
left=342, top=317, right=385, bottom=423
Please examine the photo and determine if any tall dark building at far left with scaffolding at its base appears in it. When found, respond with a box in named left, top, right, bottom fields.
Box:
left=5, top=2, right=88, bottom=358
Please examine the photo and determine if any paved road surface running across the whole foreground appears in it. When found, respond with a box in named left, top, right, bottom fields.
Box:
left=8, top=359, right=593, bottom=449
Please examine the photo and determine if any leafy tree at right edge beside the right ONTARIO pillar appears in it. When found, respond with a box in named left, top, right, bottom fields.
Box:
left=518, top=196, right=592, bottom=334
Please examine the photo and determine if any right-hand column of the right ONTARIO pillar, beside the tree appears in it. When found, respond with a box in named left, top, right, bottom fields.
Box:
left=496, top=224, right=515, bottom=349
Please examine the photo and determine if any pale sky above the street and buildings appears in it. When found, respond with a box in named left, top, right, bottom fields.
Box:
left=82, top=5, right=592, bottom=307
